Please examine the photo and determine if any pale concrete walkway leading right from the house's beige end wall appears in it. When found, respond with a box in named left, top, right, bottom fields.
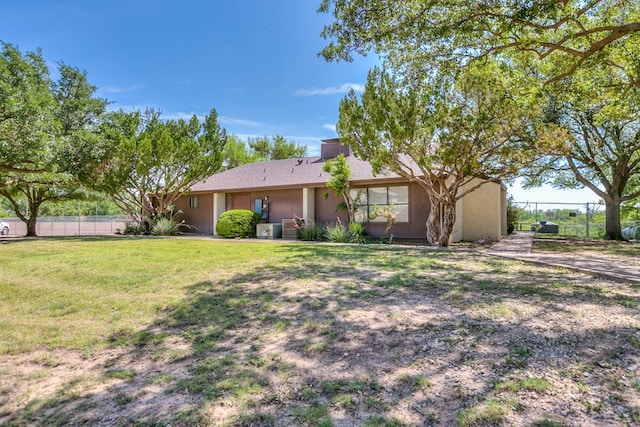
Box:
left=481, top=231, right=640, bottom=283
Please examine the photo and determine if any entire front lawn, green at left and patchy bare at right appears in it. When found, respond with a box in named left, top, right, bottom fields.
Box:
left=0, top=238, right=640, bottom=427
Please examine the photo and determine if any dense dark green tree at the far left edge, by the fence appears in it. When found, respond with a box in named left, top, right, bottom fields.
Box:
left=0, top=44, right=107, bottom=236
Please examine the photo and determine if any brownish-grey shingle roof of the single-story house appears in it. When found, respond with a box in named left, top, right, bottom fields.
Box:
left=191, top=156, right=400, bottom=192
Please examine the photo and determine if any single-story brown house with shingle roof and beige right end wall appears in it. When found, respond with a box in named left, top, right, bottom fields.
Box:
left=176, top=139, right=507, bottom=242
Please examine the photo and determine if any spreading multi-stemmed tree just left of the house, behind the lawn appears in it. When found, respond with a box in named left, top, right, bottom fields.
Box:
left=74, top=109, right=226, bottom=224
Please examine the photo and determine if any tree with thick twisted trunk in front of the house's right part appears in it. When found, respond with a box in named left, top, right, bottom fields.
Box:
left=337, top=64, right=534, bottom=246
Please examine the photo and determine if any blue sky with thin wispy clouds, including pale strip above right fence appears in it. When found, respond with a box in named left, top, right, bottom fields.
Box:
left=0, top=0, right=597, bottom=206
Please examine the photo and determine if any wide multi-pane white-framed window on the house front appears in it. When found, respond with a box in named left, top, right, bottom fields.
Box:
left=351, top=185, right=409, bottom=222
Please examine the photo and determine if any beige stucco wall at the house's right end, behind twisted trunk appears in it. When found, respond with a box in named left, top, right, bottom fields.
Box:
left=451, top=181, right=507, bottom=242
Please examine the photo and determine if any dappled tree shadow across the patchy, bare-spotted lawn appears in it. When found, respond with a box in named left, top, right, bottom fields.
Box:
left=10, top=245, right=640, bottom=426
